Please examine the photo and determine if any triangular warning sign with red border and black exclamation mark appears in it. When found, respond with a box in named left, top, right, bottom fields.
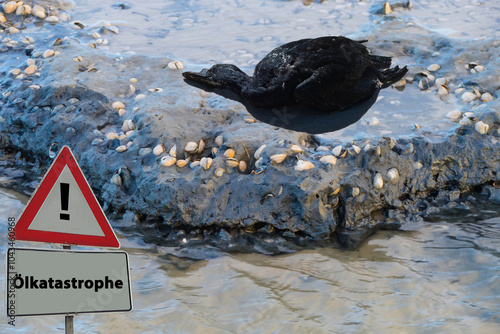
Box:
left=15, top=146, right=120, bottom=248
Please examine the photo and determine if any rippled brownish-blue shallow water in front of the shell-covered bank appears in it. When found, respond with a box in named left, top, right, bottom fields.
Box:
left=0, top=189, right=500, bottom=333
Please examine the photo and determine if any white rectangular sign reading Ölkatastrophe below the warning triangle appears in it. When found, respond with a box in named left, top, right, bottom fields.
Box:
left=7, top=248, right=132, bottom=316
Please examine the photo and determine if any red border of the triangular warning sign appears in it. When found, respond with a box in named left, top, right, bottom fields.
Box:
left=14, top=146, right=120, bottom=248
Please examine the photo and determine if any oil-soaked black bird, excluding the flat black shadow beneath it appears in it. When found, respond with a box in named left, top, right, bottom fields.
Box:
left=182, top=36, right=408, bottom=111
